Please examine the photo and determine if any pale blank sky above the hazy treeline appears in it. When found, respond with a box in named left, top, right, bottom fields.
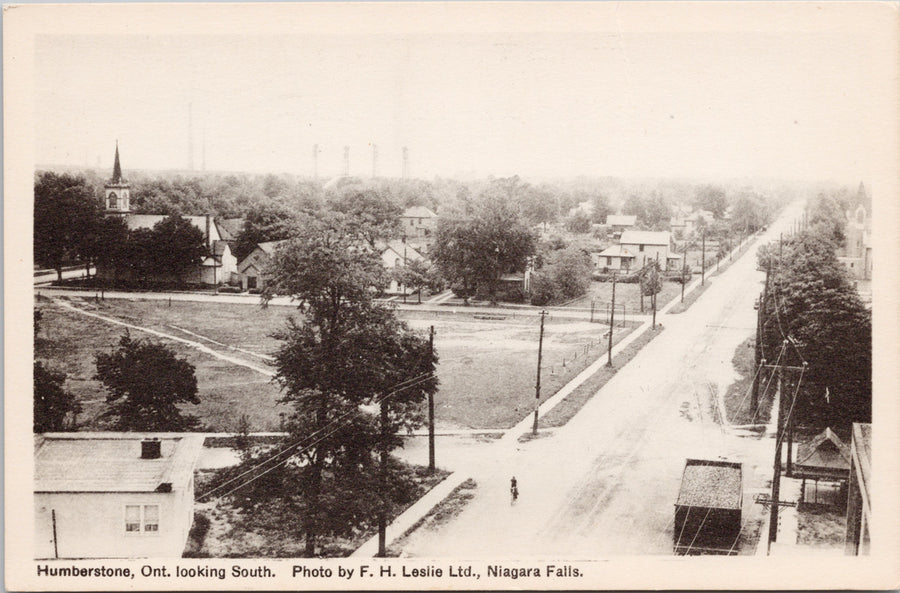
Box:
left=34, top=3, right=896, bottom=183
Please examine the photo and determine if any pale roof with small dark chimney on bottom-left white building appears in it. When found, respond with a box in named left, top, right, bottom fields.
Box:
left=34, top=432, right=203, bottom=492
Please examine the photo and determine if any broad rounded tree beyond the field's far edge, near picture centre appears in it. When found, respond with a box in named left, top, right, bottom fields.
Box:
left=433, top=196, right=535, bottom=301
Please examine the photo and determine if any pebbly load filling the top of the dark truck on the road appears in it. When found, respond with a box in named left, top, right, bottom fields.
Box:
left=675, top=459, right=743, bottom=509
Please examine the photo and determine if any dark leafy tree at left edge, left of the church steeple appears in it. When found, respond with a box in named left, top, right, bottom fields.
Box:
left=34, top=172, right=100, bottom=280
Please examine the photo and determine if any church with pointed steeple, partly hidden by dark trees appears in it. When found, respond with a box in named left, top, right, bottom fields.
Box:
left=97, top=143, right=238, bottom=286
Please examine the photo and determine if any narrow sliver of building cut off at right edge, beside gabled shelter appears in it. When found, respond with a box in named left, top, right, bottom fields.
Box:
left=844, top=422, right=872, bottom=556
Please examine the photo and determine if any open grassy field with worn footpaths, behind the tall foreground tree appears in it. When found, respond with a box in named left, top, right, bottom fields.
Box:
left=35, top=299, right=631, bottom=431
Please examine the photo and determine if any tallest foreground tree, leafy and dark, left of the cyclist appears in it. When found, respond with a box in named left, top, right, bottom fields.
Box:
left=264, top=213, right=437, bottom=556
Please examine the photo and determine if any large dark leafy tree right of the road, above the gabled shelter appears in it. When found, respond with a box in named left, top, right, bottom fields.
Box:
left=761, top=221, right=872, bottom=430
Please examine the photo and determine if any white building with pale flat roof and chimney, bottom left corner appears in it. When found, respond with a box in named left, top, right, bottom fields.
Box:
left=34, top=432, right=203, bottom=559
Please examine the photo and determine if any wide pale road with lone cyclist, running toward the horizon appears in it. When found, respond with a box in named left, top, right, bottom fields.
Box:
left=404, top=202, right=797, bottom=559
